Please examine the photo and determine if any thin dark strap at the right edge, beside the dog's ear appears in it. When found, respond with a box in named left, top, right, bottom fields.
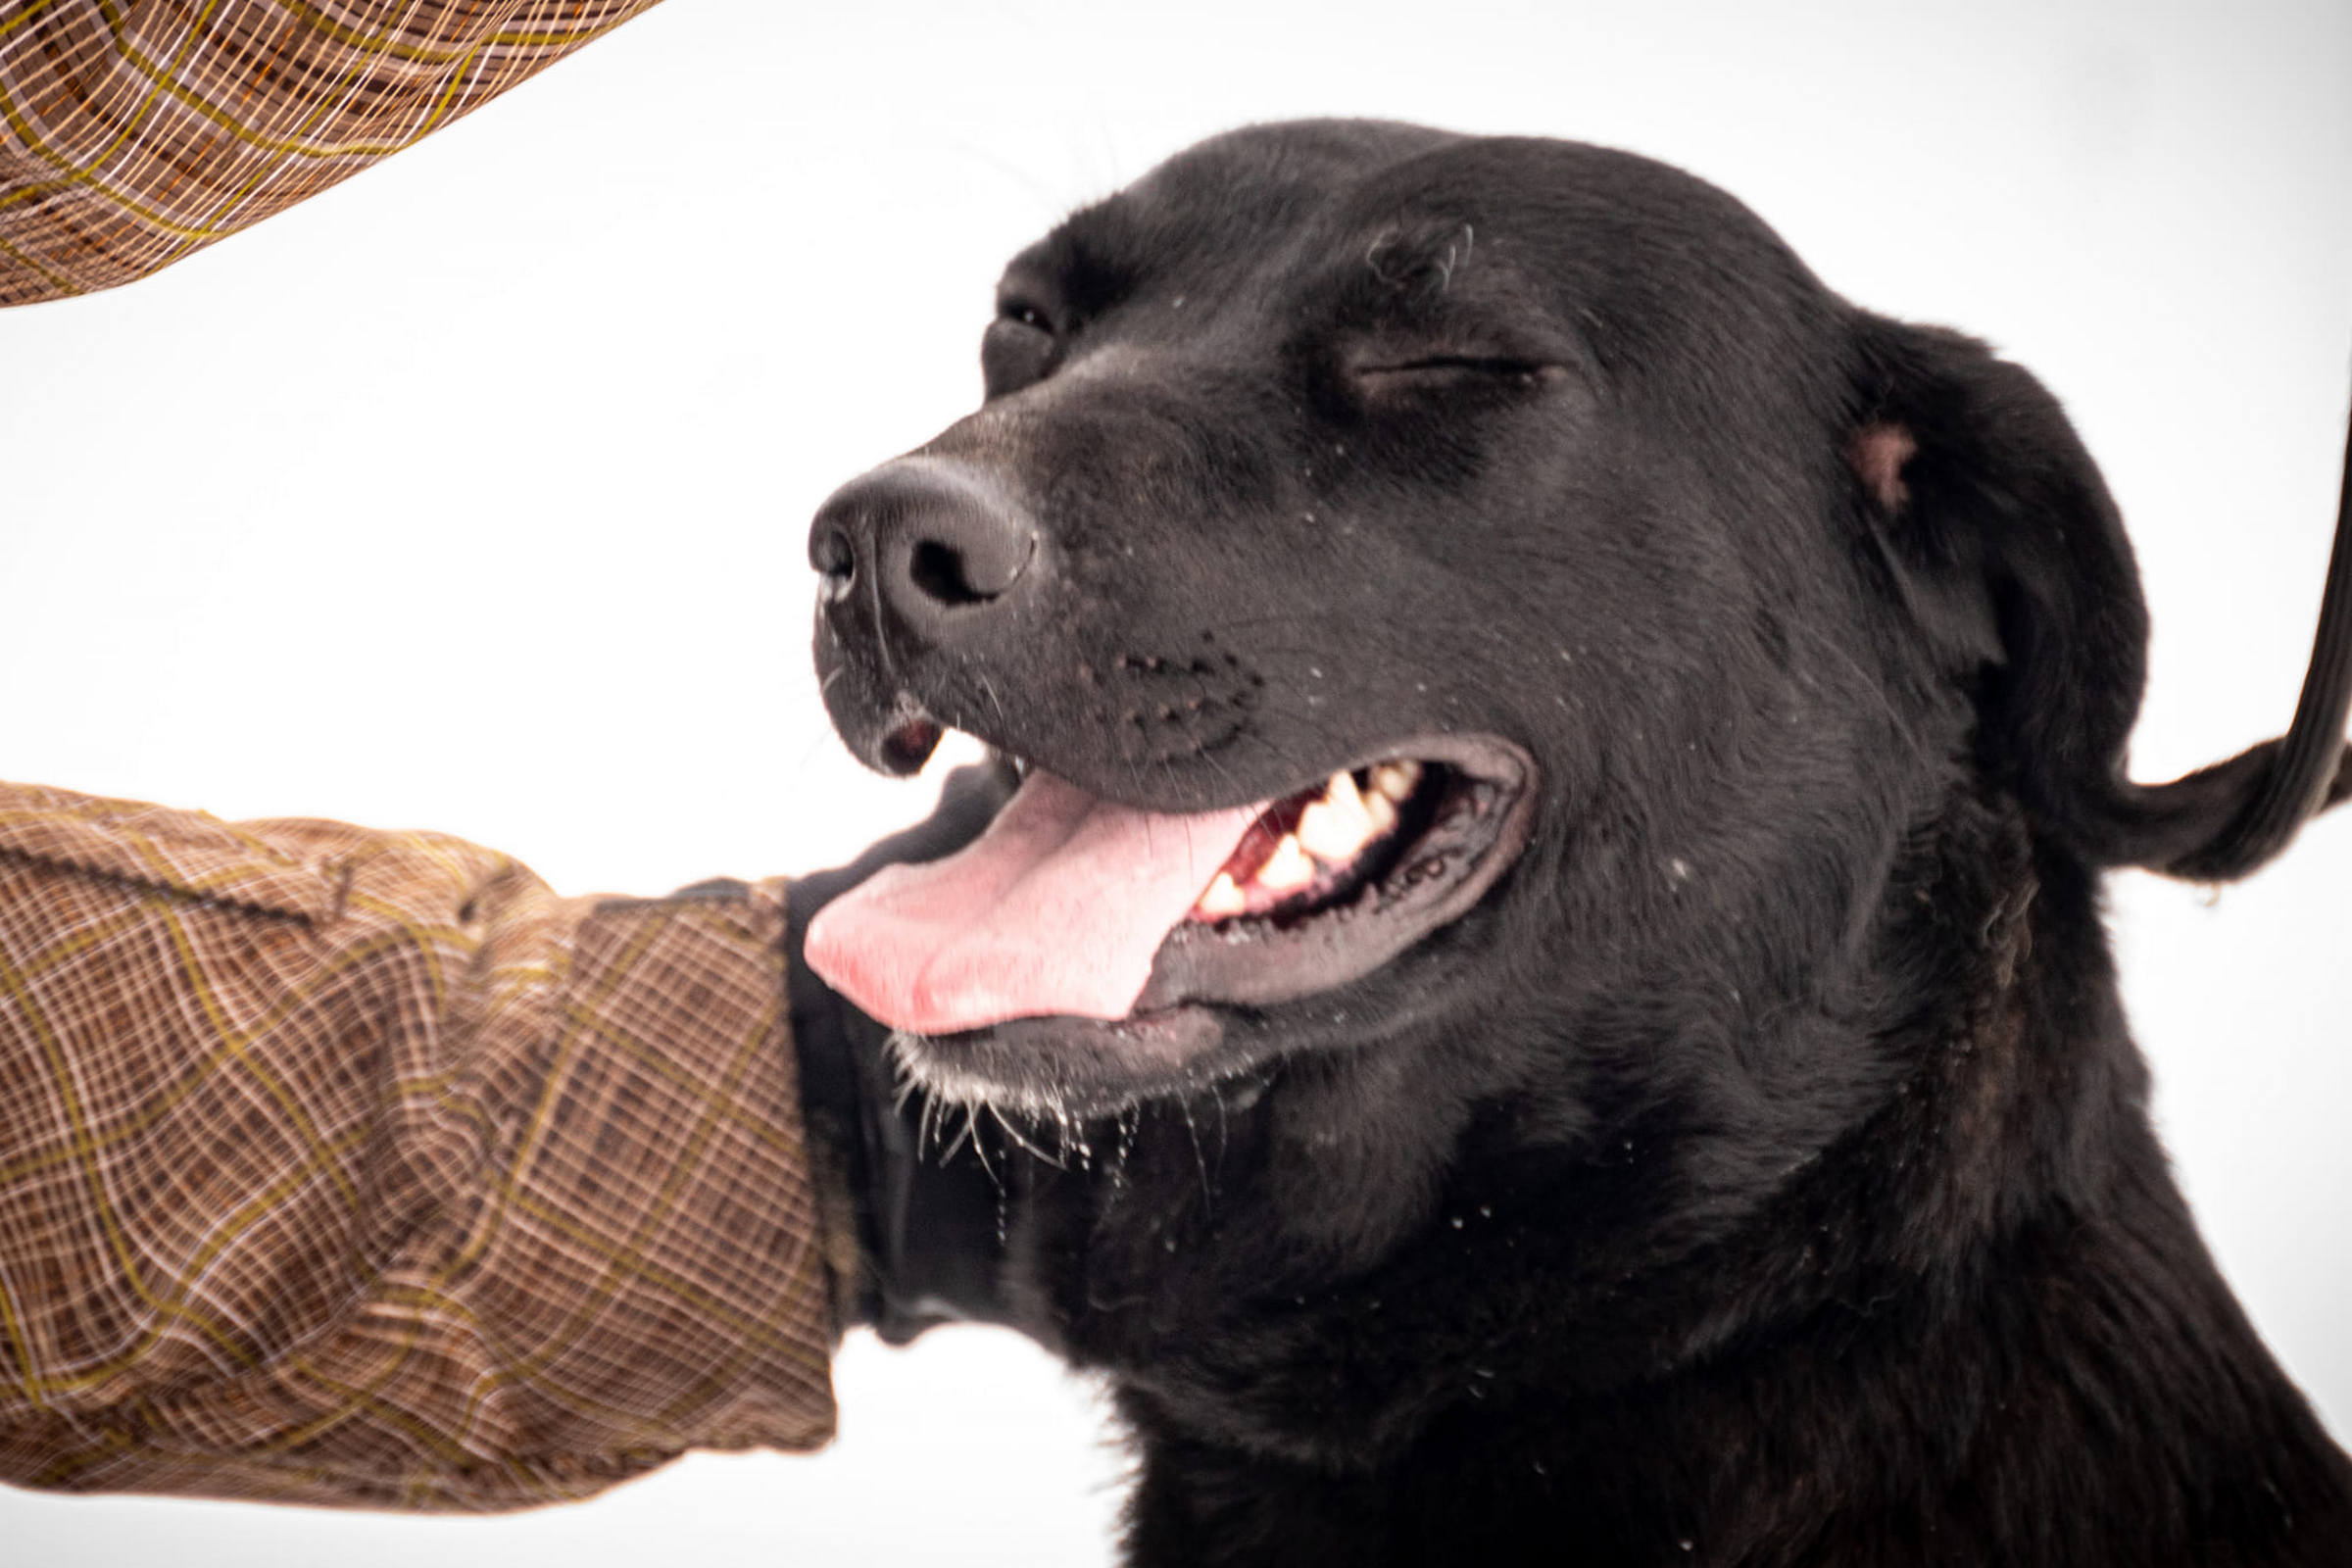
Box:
left=2157, top=392, right=2352, bottom=882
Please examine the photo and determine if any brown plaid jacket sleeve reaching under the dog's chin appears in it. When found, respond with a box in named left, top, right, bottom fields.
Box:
left=0, top=785, right=833, bottom=1504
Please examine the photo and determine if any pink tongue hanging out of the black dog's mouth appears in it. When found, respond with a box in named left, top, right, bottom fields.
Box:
left=805, top=771, right=1265, bottom=1034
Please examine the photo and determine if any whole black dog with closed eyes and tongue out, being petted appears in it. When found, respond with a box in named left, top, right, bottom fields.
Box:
left=807, top=122, right=2352, bottom=1568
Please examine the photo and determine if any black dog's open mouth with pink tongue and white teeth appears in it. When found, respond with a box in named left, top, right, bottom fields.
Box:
left=805, top=736, right=1536, bottom=1100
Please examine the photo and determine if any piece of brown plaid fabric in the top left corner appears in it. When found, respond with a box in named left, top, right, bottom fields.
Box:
left=0, top=0, right=654, bottom=306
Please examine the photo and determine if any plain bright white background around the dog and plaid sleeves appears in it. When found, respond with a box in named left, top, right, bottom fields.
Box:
left=0, top=0, right=2352, bottom=1568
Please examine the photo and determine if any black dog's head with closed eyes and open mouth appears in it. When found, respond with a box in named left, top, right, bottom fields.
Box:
left=809, top=122, right=2332, bottom=1170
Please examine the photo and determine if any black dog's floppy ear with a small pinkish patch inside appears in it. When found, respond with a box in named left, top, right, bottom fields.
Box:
left=1844, top=315, right=2352, bottom=882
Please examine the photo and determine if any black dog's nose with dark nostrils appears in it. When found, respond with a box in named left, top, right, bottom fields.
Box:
left=809, top=456, right=1037, bottom=635
